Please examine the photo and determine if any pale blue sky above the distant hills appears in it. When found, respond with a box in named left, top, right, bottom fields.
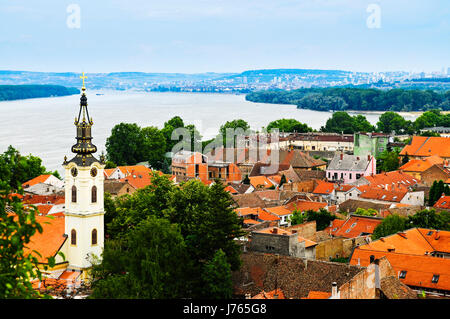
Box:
left=0, top=0, right=450, bottom=73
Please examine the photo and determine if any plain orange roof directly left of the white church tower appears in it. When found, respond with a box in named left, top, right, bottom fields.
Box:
left=25, top=215, right=67, bottom=263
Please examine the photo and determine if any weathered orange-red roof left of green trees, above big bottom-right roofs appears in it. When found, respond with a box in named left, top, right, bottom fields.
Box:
left=325, top=216, right=382, bottom=238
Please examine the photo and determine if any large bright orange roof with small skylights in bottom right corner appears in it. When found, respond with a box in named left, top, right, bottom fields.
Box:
left=349, top=250, right=450, bottom=290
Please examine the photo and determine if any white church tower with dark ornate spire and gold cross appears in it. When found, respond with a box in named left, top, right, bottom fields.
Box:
left=63, top=73, right=105, bottom=271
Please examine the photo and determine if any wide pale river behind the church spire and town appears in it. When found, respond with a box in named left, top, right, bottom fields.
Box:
left=0, top=90, right=417, bottom=176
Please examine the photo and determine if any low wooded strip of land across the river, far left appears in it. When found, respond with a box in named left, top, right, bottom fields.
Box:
left=0, top=84, right=80, bottom=101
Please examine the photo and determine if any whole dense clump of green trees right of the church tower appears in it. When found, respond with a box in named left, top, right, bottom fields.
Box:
left=94, top=174, right=243, bottom=298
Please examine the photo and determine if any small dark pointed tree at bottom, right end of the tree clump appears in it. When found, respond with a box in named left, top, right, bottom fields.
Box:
left=202, top=249, right=233, bottom=299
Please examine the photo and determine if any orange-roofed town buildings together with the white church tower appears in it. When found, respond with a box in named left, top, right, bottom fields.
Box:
left=13, top=87, right=450, bottom=299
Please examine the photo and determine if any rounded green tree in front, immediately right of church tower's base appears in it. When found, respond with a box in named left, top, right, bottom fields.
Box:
left=91, top=216, right=192, bottom=299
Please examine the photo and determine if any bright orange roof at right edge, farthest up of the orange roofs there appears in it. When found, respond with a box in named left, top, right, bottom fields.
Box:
left=400, top=136, right=450, bottom=158
